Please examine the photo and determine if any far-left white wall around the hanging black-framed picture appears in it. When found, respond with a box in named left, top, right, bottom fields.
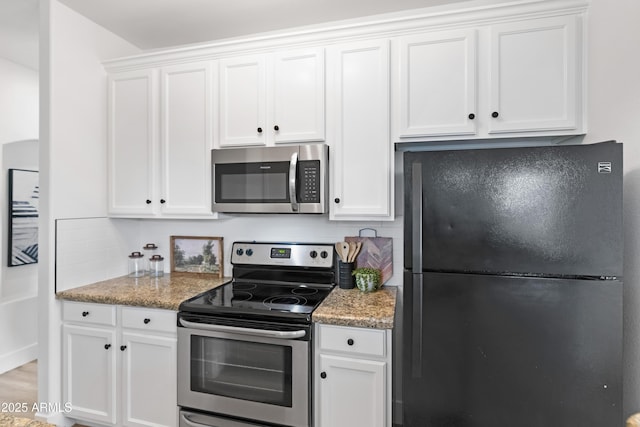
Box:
left=0, top=58, right=39, bottom=373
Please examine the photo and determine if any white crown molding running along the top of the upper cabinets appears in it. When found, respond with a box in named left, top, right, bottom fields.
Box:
left=103, top=0, right=589, bottom=72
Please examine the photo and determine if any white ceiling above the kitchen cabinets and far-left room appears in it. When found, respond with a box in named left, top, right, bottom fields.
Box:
left=0, top=0, right=472, bottom=69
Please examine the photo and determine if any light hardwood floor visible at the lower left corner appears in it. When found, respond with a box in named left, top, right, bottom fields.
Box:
left=0, top=360, right=38, bottom=419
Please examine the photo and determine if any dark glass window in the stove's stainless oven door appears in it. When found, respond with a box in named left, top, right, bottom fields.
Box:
left=191, top=335, right=292, bottom=407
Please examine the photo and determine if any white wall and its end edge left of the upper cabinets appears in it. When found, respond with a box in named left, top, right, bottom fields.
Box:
left=38, top=0, right=139, bottom=422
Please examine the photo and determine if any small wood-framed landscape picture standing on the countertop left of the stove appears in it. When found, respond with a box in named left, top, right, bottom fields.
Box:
left=170, top=236, right=224, bottom=278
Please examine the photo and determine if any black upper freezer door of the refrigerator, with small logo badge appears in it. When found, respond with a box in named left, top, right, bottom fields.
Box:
left=404, top=142, right=622, bottom=277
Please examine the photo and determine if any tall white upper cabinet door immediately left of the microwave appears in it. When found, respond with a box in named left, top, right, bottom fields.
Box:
left=160, top=62, right=213, bottom=216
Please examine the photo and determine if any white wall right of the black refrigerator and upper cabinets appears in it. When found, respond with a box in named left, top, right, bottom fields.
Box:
left=585, top=0, right=640, bottom=415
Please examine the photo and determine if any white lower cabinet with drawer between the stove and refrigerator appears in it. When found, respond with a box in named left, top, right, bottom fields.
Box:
left=314, top=324, right=392, bottom=427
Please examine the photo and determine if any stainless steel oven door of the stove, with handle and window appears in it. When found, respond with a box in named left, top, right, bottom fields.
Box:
left=178, top=315, right=311, bottom=427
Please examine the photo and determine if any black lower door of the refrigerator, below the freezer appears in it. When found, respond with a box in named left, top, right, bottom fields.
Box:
left=402, top=273, right=623, bottom=427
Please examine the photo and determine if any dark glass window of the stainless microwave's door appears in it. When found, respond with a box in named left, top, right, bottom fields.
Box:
left=214, top=162, right=289, bottom=203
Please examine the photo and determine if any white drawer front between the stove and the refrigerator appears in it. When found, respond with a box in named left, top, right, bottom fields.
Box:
left=318, top=325, right=385, bottom=357
